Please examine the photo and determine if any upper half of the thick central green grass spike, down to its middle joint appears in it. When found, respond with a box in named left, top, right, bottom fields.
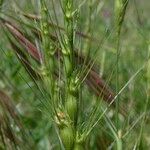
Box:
left=62, top=0, right=74, bottom=77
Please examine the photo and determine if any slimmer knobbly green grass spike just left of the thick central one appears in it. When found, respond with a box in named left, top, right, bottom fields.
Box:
left=40, top=0, right=58, bottom=114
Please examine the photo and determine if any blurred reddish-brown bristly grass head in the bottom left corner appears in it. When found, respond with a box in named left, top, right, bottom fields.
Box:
left=0, top=89, right=34, bottom=149
